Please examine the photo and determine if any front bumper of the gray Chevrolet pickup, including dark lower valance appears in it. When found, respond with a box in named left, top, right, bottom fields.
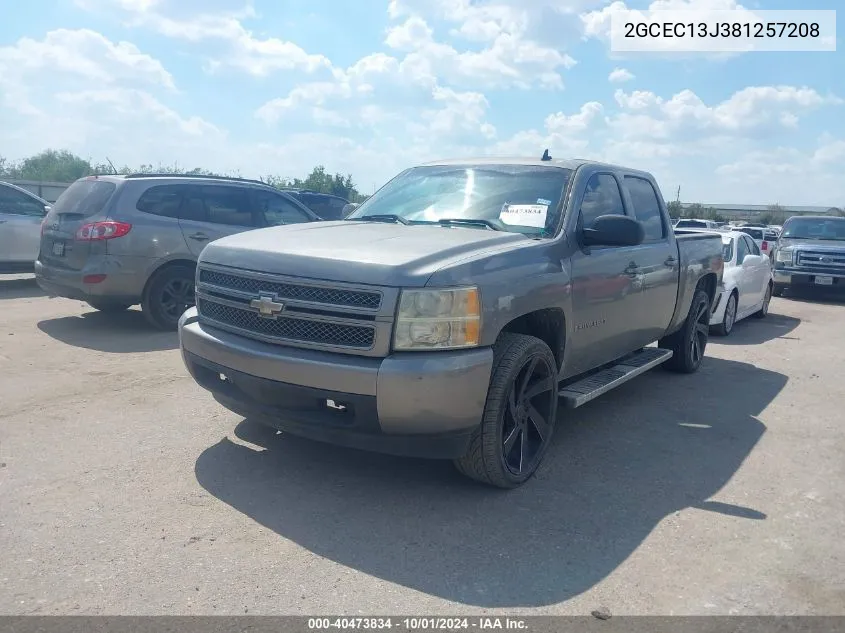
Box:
left=179, top=308, right=493, bottom=459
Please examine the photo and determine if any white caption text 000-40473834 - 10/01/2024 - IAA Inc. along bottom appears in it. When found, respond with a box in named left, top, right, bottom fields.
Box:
left=308, top=617, right=528, bottom=631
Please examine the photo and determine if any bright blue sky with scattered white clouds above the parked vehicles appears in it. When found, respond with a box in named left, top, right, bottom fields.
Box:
left=0, top=0, right=845, bottom=206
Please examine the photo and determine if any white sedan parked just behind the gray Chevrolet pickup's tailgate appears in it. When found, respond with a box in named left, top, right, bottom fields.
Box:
left=710, top=231, right=773, bottom=336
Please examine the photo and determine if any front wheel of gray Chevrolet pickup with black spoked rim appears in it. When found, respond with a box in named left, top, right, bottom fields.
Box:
left=455, top=332, right=558, bottom=489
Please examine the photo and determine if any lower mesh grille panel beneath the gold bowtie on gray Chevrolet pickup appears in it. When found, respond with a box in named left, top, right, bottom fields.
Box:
left=197, top=299, right=375, bottom=349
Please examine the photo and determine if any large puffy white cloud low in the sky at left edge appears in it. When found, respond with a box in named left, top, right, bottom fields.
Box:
left=0, top=29, right=221, bottom=165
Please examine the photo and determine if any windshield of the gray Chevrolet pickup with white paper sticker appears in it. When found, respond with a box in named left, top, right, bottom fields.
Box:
left=346, top=165, right=572, bottom=237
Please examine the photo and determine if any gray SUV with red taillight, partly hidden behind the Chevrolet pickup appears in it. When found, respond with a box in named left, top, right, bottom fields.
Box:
left=35, top=174, right=320, bottom=330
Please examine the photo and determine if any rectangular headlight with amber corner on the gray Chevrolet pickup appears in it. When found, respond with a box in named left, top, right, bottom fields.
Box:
left=393, top=287, right=481, bottom=350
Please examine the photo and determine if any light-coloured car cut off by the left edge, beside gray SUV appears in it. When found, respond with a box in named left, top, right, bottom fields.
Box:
left=0, top=182, right=50, bottom=273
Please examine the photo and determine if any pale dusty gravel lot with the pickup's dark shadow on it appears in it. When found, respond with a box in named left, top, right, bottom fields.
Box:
left=0, top=276, right=845, bottom=615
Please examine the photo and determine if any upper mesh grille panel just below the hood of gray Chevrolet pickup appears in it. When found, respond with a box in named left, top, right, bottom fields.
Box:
left=200, top=270, right=381, bottom=310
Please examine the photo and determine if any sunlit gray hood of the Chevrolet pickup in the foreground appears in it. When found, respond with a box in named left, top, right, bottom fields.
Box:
left=200, top=221, right=532, bottom=287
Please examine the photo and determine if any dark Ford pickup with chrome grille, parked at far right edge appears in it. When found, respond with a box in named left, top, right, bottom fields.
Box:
left=772, top=215, right=845, bottom=297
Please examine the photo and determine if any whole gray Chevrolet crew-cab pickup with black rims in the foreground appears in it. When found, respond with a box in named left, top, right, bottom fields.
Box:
left=179, top=155, right=723, bottom=488
